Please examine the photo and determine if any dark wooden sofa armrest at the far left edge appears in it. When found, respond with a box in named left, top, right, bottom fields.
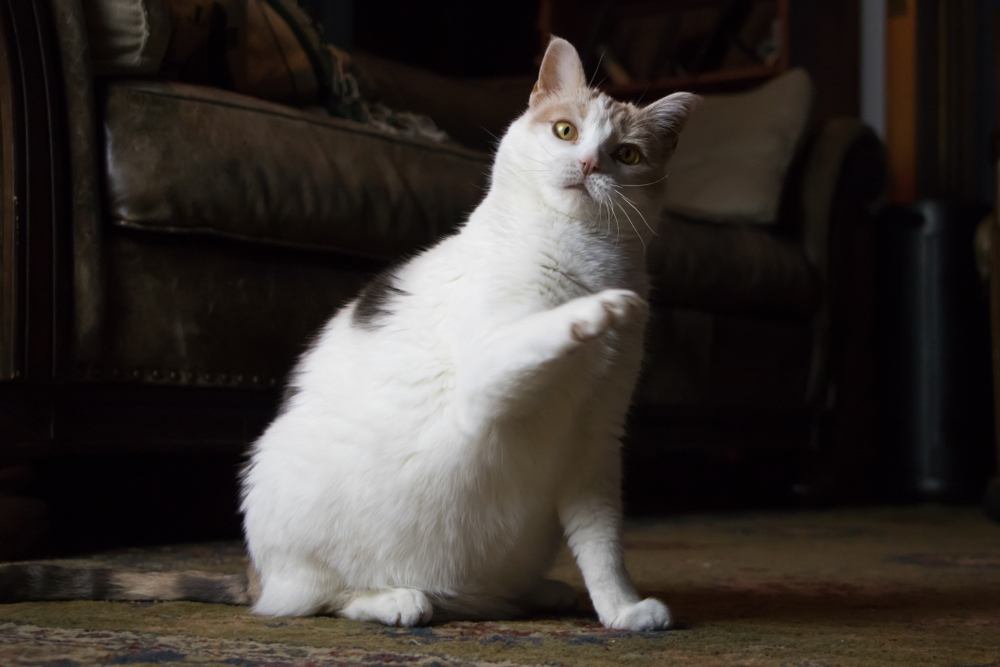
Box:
left=0, top=0, right=101, bottom=382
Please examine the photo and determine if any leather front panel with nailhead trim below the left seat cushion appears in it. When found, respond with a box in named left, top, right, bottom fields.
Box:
left=79, top=237, right=371, bottom=388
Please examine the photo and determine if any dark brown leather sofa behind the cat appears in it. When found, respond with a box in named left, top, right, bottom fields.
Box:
left=0, top=0, right=884, bottom=556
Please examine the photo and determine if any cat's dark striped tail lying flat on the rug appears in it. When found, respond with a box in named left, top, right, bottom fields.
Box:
left=0, top=563, right=251, bottom=605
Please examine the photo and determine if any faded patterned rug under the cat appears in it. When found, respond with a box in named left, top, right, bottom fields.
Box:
left=0, top=507, right=1000, bottom=667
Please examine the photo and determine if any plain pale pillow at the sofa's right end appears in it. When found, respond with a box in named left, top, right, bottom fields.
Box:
left=665, top=69, right=813, bottom=224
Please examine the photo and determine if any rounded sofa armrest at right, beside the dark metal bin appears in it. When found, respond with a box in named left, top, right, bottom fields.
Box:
left=799, top=118, right=887, bottom=480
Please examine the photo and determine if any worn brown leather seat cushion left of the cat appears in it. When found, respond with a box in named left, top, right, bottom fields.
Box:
left=105, top=82, right=490, bottom=258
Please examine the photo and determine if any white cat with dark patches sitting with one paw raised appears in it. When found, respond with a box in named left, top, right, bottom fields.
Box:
left=0, top=37, right=697, bottom=630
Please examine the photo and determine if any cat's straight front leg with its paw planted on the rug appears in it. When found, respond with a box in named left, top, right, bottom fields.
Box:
left=559, top=450, right=671, bottom=631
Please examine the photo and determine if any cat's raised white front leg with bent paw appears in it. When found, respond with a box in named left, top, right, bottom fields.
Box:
left=458, top=289, right=648, bottom=428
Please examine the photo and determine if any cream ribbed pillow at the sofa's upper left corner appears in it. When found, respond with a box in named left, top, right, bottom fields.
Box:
left=83, top=0, right=171, bottom=75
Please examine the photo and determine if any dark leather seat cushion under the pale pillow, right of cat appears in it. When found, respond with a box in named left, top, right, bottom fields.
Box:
left=648, top=215, right=821, bottom=318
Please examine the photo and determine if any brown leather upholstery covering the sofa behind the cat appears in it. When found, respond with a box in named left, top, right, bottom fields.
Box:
left=0, top=0, right=884, bottom=448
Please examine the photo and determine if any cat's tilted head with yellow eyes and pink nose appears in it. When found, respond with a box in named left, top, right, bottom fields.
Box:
left=494, top=37, right=698, bottom=236
